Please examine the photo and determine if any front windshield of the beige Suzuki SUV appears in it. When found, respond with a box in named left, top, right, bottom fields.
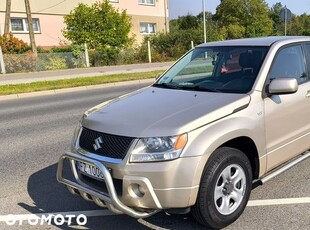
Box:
left=154, top=46, right=268, bottom=93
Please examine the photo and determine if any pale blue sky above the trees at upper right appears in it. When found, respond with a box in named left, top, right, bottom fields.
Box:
left=169, top=0, right=310, bottom=19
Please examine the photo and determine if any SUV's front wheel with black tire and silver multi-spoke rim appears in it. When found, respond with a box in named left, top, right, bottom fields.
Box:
left=191, top=147, right=252, bottom=229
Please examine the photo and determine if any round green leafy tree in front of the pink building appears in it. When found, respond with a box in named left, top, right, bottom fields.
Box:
left=63, top=0, right=132, bottom=49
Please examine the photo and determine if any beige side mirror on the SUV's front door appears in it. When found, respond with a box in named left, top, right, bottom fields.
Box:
left=268, top=78, right=298, bottom=95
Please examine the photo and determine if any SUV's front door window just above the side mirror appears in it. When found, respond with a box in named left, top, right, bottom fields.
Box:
left=269, top=45, right=307, bottom=84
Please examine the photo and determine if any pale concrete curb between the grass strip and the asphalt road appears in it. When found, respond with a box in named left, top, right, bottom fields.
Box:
left=0, top=79, right=155, bottom=101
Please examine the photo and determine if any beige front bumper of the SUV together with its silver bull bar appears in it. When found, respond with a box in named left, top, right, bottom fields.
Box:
left=57, top=152, right=206, bottom=218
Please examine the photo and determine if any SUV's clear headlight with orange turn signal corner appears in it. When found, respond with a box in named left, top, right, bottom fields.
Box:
left=130, top=134, right=187, bottom=163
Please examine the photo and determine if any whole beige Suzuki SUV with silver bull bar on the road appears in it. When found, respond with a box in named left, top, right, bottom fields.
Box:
left=57, top=37, right=310, bottom=229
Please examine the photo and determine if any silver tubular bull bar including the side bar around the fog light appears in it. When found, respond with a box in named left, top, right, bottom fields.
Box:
left=57, top=153, right=162, bottom=218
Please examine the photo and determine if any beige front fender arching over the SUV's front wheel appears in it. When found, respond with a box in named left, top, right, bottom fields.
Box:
left=181, top=98, right=266, bottom=188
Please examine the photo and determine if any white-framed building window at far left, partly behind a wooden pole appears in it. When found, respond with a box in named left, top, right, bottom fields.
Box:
left=11, top=18, right=41, bottom=33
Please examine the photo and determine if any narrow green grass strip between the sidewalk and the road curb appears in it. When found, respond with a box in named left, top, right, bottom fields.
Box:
left=0, top=70, right=163, bottom=95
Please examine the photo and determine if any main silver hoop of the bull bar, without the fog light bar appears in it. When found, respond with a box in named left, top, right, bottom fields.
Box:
left=57, top=152, right=159, bottom=218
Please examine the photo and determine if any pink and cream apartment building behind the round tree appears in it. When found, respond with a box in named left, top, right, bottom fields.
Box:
left=0, top=0, right=169, bottom=47
